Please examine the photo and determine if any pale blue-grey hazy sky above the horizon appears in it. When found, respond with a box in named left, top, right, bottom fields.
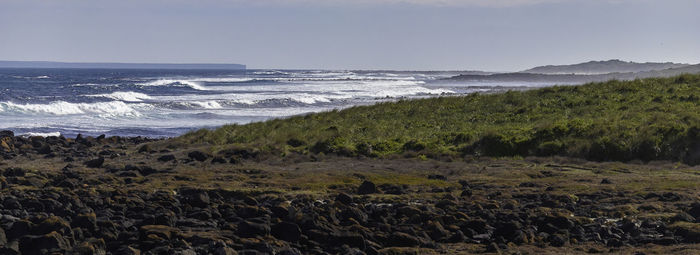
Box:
left=0, top=0, right=700, bottom=71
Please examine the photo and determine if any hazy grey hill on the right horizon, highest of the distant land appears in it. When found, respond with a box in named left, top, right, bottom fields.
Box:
left=522, top=59, right=688, bottom=75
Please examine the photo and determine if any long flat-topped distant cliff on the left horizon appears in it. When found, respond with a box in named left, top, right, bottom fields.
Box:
left=0, top=61, right=246, bottom=70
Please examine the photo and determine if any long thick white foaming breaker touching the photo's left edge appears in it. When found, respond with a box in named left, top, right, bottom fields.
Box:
left=0, top=101, right=140, bottom=117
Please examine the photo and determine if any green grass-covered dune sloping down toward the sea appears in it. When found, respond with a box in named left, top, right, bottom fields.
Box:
left=171, top=75, right=700, bottom=164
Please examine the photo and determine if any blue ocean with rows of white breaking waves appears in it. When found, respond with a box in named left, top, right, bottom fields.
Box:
left=0, top=68, right=540, bottom=138
